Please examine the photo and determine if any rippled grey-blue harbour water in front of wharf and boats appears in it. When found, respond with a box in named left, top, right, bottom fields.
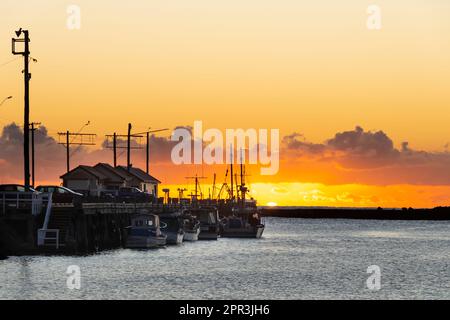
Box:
left=0, top=218, right=450, bottom=299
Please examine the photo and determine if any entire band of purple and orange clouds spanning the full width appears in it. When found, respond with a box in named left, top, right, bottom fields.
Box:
left=0, top=123, right=450, bottom=188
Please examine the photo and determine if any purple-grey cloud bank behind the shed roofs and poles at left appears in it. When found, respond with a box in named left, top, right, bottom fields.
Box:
left=0, top=123, right=183, bottom=183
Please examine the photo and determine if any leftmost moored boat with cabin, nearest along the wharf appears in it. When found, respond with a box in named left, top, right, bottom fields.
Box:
left=125, top=213, right=167, bottom=249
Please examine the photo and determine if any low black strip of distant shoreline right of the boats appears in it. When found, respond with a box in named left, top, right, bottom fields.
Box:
left=260, top=206, right=450, bottom=220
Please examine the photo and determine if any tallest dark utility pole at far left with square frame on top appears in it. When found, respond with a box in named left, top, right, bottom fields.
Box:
left=12, top=28, right=31, bottom=191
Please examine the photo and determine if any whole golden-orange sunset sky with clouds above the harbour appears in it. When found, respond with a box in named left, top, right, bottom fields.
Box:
left=0, top=0, right=450, bottom=207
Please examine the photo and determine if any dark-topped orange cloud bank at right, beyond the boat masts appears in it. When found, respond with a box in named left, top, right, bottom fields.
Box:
left=281, top=126, right=450, bottom=184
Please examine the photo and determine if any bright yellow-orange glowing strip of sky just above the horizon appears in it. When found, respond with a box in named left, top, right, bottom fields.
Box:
left=160, top=183, right=450, bottom=208
